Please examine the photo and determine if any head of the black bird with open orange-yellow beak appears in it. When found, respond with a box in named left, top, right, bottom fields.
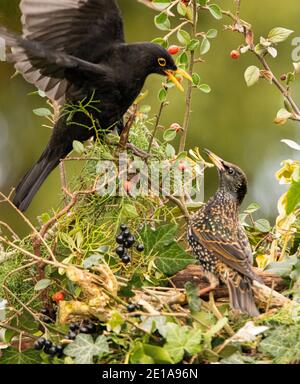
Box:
left=134, top=43, right=192, bottom=91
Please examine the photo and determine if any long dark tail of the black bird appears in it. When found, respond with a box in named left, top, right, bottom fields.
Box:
left=13, top=147, right=69, bottom=211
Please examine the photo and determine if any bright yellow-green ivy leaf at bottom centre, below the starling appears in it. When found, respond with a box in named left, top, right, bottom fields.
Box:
left=164, top=324, right=202, bottom=363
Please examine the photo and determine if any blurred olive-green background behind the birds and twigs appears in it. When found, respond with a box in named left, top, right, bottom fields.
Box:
left=0, top=0, right=300, bottom=234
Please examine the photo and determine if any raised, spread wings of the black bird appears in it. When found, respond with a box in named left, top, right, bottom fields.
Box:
left=0, top=0, right=124, bottom=104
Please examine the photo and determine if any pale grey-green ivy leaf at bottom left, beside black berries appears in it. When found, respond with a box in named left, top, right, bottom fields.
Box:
left=64, top=333, right=109, bottom=364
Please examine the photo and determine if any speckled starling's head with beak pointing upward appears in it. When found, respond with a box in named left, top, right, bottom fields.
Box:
left=205, top=149, right=248, bottom=204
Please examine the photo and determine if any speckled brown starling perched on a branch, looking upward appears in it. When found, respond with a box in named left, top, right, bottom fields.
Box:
left=188, top=150, right=260, bottom=316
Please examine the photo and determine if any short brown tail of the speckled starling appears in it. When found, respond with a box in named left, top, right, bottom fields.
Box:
left=227, top=277, right=259, bottom=317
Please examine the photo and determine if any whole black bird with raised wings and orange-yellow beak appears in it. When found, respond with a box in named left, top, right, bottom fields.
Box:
left=0, top=0, right=191, bottom=211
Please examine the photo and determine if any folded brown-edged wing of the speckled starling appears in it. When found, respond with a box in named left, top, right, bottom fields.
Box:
left=193, top=229, right=256, bottom=280
